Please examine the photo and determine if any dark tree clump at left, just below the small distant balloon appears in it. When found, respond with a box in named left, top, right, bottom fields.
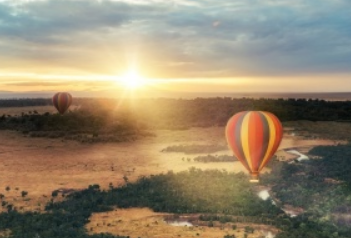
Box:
left=0, top=108, right=153, bottom=142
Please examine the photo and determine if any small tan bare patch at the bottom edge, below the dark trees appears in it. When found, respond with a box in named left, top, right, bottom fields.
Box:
left=86, top=208, right=278, bottom=238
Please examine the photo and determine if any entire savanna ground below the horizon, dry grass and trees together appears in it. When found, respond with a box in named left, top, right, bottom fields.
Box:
left=0, top=98, right=351, bottom=238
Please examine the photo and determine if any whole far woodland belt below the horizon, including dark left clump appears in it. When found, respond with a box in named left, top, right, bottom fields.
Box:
left=0, top=97, right=351, bottom=142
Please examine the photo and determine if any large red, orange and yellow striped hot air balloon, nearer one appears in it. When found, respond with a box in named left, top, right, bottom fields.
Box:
left=225, top=111, right=283, bottom=182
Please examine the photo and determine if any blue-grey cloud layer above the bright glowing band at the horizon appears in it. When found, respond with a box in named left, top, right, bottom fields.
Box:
left=0, top=0, right=351, bottom=78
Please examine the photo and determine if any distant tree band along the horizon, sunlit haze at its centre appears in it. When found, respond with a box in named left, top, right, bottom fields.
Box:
left=0, top=97, right=351, bottom=127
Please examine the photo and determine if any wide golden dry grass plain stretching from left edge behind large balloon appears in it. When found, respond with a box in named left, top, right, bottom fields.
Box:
left=0, top=127, right=335, bottom=209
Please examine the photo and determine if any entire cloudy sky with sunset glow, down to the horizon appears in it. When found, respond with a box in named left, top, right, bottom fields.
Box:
left=0, top=0, right=351, bottom=95
